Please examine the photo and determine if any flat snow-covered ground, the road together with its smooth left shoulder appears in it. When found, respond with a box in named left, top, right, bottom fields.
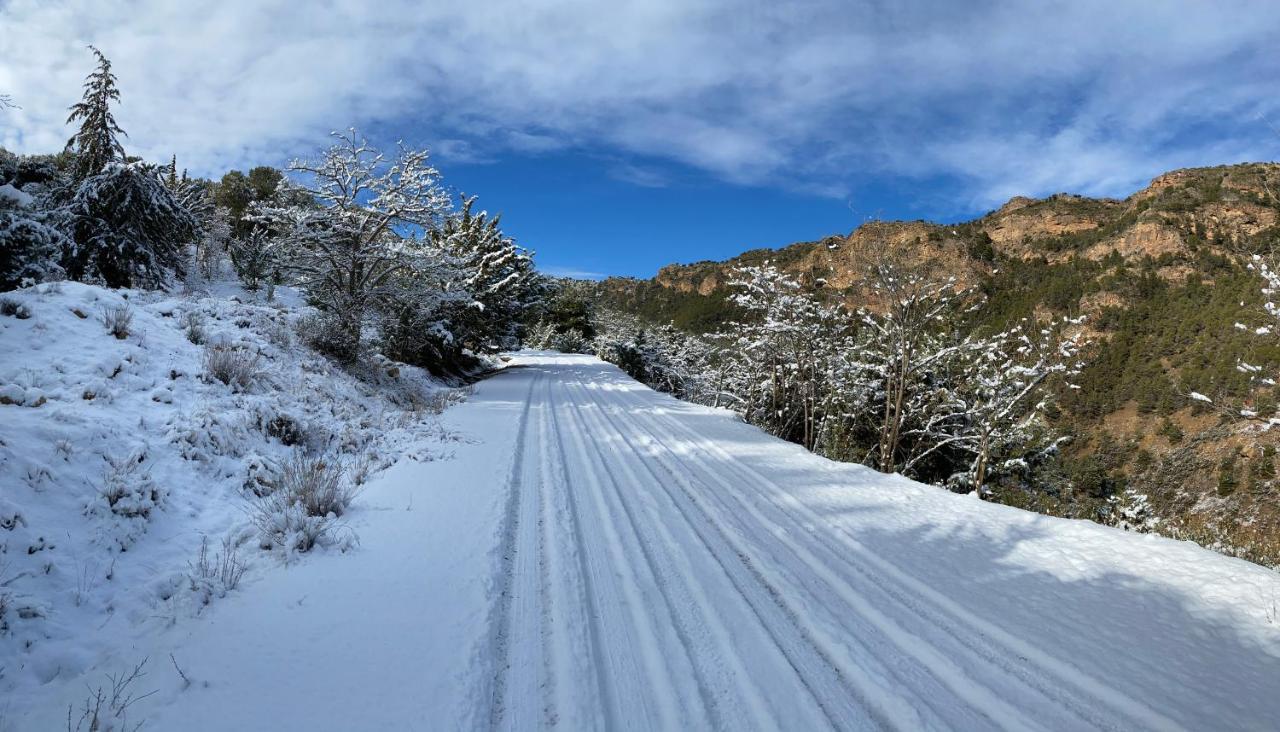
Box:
left=0, top=350, right=1280, bottom=731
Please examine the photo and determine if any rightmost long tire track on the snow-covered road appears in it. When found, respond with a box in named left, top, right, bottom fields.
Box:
left=593, top=376, right=1180, bottom=729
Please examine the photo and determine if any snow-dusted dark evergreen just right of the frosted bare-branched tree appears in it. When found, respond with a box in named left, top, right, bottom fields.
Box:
left=431, top=196, right=541, bottom=352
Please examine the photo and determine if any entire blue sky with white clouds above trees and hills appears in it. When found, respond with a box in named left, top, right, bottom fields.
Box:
left=0, top=0, right=1280, bottom=276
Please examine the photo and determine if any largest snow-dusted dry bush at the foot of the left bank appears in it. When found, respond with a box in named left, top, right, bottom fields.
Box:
left=251, top=450, right=357, bottom=553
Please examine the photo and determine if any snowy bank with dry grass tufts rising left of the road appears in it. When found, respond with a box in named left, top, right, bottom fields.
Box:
left=0, top=283, right=460, bottom=729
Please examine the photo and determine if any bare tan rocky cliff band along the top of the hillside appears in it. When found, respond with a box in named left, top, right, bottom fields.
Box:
left=645, top=164, right=1280, bottom=296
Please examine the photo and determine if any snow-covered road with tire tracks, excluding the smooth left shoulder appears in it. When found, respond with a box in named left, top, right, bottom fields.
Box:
left=476, top=357, right=1280, bottom=729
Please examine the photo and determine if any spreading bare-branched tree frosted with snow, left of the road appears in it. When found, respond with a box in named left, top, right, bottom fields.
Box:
left=252, top=129, right=452, bottom=360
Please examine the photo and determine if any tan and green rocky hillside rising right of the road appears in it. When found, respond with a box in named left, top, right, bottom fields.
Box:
left=595, top=164, right=1280, bottom=564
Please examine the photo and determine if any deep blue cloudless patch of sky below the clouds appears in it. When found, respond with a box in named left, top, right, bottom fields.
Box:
left=443, top=151, right=927, bottom=278
